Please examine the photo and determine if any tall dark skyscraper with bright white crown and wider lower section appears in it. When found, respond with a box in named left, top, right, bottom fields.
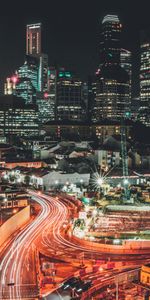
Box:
left=92, top=15, right=130, bottom=122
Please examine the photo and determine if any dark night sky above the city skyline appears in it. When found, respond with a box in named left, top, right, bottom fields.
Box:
left=0, top=0, right=150, bottom=91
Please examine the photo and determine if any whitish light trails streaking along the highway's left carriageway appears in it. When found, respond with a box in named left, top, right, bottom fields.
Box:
left=0, top=193, right=50, bottom=299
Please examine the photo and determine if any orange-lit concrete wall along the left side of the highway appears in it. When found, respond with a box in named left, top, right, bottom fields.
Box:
left=0, top=205, right=30, bottom=246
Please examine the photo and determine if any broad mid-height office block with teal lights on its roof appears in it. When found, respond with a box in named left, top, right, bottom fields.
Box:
left=56, top=69, right=85, bottom=121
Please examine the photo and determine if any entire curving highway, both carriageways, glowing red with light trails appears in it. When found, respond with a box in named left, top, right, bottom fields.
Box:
left=0, top=191, right=148, bottom=300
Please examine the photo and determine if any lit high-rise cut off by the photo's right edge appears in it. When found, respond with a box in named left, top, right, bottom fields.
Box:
left=140, top=30, right=150, bottom=126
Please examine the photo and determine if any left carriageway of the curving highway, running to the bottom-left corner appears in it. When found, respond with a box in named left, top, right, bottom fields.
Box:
left=0, top=193, right=50, bottom=299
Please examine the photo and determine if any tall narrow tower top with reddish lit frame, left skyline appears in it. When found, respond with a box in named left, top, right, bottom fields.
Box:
left=26, top=23, right=41, bottom=55
